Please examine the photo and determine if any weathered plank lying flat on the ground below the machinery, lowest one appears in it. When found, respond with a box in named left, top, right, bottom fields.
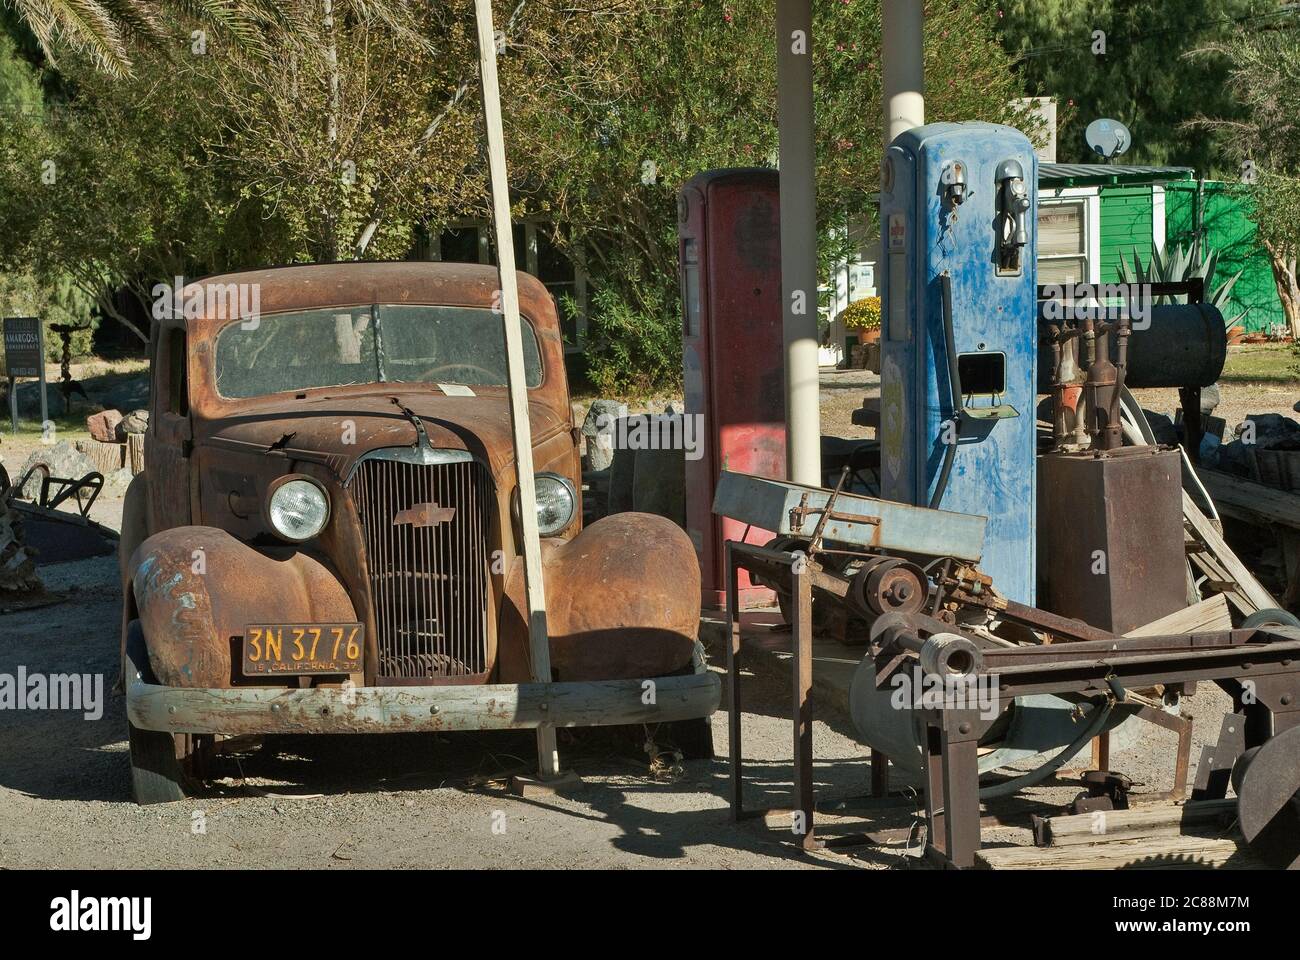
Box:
left=975, top=836, right=1268, bottom=870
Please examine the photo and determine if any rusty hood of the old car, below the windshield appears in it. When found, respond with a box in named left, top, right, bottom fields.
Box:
left=195, top=384, right=569, bottom=480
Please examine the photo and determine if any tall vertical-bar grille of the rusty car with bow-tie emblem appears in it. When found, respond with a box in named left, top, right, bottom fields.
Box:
left=348, top=457, right=495, bottom=684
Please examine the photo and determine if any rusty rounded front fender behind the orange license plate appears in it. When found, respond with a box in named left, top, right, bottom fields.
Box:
left=127, top=527, right=358, bottom=687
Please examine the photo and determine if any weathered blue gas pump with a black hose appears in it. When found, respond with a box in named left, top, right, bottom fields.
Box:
left=880, top=122, right=1037, bottom=604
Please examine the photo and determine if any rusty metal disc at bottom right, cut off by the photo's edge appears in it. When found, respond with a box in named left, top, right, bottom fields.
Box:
left=1232, top=726, right=1300, bottom=870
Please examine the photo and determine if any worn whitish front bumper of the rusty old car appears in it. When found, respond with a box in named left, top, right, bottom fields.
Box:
left=126, top=650, right=722, bottom=736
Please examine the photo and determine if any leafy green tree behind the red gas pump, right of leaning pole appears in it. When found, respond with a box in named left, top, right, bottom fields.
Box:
left=506, top=0, right=1032, bottom=390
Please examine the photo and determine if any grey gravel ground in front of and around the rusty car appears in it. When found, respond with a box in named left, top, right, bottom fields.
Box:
left=0, top=361, right=1279, bottom=869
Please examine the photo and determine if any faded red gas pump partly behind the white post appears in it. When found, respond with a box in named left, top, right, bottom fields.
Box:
left=677, top=169, right=785, bottom=607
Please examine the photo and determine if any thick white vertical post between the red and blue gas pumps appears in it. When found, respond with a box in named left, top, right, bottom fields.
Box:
left=776, top=0, right=822, bottom=487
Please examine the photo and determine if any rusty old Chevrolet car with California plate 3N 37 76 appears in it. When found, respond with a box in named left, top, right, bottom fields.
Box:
left=120, top=263, right=720, bottom=803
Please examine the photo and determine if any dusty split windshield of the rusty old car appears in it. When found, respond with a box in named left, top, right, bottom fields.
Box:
left=216, top=303, right=542, bottom=399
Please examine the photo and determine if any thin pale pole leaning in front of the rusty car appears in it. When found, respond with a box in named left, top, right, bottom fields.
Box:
left=475, top=0, right=560, bottom=778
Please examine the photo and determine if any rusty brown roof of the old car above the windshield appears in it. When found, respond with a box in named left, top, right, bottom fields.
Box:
left=169, top=260, right=554, bottom=336
